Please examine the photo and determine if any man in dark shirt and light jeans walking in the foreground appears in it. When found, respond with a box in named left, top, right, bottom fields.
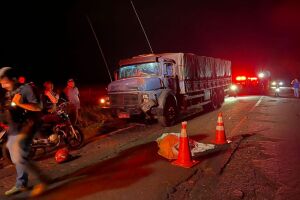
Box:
left=0, top=67, right=46, bottom=196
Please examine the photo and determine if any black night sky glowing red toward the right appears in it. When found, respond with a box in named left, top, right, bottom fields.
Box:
left=0, top=0, right=300, bottom=85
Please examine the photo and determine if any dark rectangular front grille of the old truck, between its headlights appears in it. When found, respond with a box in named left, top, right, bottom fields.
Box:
left=109, top=94, right=139, bottom=106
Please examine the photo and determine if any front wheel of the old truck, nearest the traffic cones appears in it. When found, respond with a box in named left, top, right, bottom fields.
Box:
left=157, top=99, right=177, bottom=126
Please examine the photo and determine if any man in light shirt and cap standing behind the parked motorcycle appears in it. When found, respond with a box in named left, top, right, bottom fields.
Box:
left=64, top=79, right=80, bottom=124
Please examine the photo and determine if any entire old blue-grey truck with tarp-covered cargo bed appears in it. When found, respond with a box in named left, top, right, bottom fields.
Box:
left=103, top=53, right=231, bottom=126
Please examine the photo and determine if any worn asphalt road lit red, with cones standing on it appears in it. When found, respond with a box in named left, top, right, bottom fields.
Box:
left=0, top=87, right=300, bottom=200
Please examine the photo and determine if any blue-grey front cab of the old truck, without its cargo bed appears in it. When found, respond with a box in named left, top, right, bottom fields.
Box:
left=108, top=54, right=178, bottom=124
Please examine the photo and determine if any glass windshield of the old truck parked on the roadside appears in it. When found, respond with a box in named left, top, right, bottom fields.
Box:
left=119, top=62, right=159, bottom=79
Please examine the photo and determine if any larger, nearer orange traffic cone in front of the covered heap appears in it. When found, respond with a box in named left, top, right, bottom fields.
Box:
left=172, top=121, right=199, bottom=168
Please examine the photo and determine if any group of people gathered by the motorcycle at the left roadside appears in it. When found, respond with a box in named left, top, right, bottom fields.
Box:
left=0, top=67, right=80, bottom=196
